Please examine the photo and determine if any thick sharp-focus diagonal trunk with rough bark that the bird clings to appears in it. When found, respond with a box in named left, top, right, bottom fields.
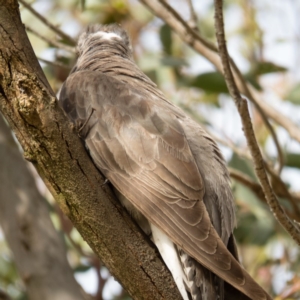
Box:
left=0, top=0, right=181, bottom=300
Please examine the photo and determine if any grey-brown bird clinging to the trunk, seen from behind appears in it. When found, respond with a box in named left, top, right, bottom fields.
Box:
left=58, top=24, right=272, bottom=300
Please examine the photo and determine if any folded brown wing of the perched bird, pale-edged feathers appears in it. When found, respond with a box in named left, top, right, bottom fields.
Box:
left=60, top=71, right=271, bottom=300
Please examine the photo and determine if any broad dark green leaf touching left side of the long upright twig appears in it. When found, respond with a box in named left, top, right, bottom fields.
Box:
left=189, top=72, right=228, bottom=94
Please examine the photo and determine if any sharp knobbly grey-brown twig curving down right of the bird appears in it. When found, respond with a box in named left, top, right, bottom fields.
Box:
left=214, top=0, right=300, bottom=245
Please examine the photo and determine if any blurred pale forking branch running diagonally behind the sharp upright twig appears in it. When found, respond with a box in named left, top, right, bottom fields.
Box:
left=140, top=0, right=300, bottom=162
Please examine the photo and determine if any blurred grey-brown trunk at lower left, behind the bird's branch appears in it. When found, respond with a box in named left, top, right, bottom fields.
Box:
left=0, top=116, right=84, bottom=300
